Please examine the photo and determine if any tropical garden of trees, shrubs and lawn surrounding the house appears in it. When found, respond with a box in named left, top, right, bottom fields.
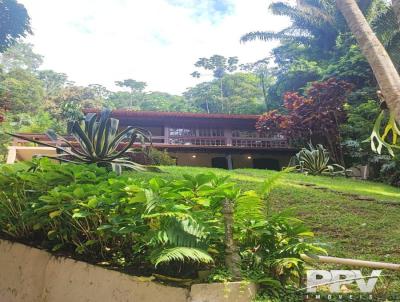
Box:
left=0, top=0, right=400, bottom=301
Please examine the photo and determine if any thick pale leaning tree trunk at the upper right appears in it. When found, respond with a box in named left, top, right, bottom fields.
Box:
left=336, top=0, right=400, bottom=122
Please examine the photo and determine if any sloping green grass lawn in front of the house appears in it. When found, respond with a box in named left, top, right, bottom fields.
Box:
left=137, top=167, right=400, bottom=263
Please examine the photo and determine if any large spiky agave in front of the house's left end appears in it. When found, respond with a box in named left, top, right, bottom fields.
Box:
left=8, top=109, right=155, bottom=173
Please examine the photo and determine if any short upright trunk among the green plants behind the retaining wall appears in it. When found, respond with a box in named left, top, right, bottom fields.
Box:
left=221, top=199, right=241, bottom=280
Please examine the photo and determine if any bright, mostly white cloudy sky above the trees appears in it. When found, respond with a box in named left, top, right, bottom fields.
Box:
left=19, top=0, right=288, bottom=94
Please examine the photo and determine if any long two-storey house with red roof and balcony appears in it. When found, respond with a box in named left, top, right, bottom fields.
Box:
left=10, top=110, right=296, bottom=170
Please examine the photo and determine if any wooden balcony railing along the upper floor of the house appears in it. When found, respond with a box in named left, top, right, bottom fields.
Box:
left=13, top=133, right=289, bottom=149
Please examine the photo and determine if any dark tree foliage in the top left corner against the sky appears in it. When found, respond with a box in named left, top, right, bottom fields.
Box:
left=0, top=0, right=32, bottom=53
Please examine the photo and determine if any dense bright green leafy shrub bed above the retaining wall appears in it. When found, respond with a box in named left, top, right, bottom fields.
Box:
left=0, top=158, right=321, bottom=284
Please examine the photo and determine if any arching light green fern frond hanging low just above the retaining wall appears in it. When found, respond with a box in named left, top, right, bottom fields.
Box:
left=151, top=247, right=214, bottom=266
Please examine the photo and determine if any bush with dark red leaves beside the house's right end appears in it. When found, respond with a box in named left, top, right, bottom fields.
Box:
left=256, top=78, right=352, bottom=163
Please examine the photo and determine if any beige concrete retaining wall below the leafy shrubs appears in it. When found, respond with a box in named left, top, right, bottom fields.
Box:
left=0, top=240, right=256, bottom=302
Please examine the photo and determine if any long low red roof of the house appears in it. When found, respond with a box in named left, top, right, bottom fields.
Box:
left=85, top=109, right=260, bottom=121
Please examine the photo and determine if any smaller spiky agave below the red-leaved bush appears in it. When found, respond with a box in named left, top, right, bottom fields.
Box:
left=290, top=143, right=350, bottom=176
